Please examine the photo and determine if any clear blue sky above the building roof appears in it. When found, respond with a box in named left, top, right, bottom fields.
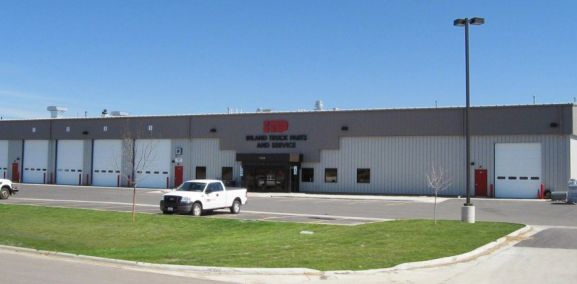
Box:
left=0, top=0, right=577, bottom=118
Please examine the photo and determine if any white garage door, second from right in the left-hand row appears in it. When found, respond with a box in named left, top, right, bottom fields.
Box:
left=92, top=140, right=122, bottom=186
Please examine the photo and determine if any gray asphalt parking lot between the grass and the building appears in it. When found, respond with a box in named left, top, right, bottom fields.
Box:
left=0, top=184, right=577, bottom=227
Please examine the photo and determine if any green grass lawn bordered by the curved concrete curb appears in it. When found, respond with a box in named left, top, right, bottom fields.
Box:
left=0, top=205, right=523, bottom=270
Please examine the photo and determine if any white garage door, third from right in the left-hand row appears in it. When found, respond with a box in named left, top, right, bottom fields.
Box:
left=56, top=140, right=85, bottom=185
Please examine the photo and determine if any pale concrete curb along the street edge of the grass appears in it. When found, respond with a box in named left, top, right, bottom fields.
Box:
left=0, top=226, right=532, bottom=276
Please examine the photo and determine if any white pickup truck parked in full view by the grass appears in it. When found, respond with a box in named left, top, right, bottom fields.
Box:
left=160, top=179, right=246, bottom=216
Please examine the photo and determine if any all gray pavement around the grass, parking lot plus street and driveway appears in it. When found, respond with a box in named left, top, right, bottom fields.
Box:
left=0, top=185, right=577, bottom=284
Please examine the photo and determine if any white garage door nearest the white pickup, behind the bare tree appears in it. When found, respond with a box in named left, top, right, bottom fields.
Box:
left=134, top=139, right=171, bottom=188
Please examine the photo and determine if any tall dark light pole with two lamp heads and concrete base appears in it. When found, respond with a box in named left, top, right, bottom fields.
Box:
left=453, top=17, right=485, bottom=223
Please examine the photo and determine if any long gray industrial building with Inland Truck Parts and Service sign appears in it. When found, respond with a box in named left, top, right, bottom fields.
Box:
left=0, top=104, right=577, bottom=198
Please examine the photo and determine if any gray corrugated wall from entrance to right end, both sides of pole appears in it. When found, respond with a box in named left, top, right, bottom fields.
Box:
left=300, top=135, right=569, bottom=195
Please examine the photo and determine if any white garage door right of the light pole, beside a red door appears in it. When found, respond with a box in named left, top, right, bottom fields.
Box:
left=495, top=143, right=542, bottom=198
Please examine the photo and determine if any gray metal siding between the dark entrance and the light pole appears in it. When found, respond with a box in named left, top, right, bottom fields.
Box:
left=300, top=136, right=465, bottom=195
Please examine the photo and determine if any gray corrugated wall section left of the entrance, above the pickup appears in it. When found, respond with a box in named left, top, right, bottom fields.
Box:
left=189, top=138, right=240, bottom=184
